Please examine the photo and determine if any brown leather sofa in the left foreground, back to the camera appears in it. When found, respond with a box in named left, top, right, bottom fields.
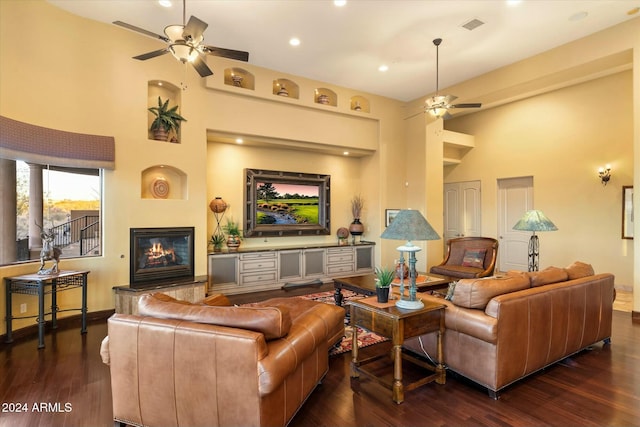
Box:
left=101, top=294, right=344, bottom=427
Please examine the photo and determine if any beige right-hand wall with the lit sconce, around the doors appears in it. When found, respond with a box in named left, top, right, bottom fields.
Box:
left=445, top=71, right=633, bottom=289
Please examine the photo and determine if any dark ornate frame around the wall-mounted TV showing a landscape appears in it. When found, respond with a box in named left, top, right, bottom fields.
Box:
left=243, top=169, right=331, bottom=237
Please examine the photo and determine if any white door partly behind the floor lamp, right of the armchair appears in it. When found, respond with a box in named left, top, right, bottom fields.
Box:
left=498, top=177, right=533, bottom=271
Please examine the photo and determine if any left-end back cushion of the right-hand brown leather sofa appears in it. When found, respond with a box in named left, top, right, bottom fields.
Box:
left=451, top=275, right=530, bottom=310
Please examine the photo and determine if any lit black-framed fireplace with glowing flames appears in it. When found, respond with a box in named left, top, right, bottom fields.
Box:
left=129, top=227, right=194, bottom=289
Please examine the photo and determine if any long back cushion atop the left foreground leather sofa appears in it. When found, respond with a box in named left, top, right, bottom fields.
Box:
left=138, top=294, right=291, bottom=340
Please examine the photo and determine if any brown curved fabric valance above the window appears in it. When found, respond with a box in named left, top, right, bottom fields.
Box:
left=0, top=116, right=116, bottom=169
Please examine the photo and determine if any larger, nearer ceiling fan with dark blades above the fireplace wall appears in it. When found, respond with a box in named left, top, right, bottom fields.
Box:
left=113, top=0, right=249, bottom=77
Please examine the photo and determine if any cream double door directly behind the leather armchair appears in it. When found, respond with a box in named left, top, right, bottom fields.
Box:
left=443, top=181, right=481, bottom=244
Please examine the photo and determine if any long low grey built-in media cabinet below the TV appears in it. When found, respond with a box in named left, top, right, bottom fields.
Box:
left=208, top=243, right=375, bottom=295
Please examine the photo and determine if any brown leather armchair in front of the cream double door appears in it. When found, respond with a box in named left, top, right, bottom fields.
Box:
left=429, top=237, right=498, bottom=279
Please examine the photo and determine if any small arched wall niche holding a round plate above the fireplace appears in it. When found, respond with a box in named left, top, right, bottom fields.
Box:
left=140, top=165, right=187, bottom=200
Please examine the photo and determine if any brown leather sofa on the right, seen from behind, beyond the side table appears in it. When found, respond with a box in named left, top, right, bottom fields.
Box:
left=405, top=262, right=615, bottom=398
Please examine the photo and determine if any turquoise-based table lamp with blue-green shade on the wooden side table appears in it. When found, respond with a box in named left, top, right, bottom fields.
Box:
left=380, top=209, right=440, bottom=309
